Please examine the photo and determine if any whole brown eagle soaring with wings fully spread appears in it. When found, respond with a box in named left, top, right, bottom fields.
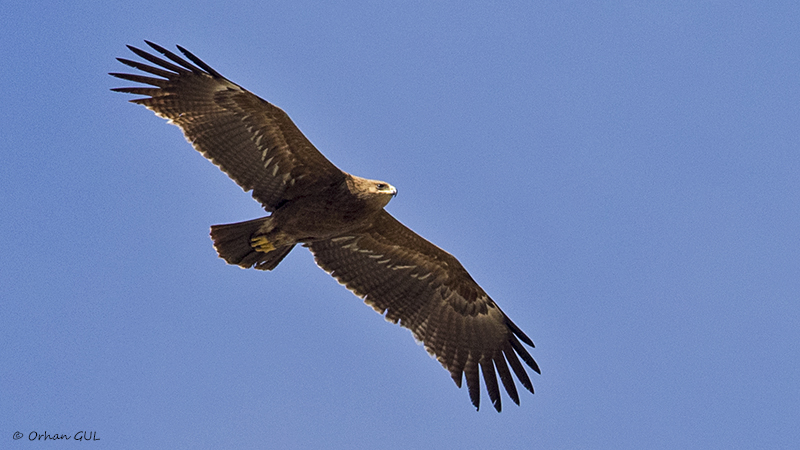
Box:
left=109, top=41, right=541, bottom=412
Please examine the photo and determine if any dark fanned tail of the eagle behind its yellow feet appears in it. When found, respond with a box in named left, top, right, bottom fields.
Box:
left=211, top=217, right=294, bottom=270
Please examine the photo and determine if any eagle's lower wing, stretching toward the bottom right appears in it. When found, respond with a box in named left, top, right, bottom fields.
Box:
left=305, top=211, right=540, bottom=411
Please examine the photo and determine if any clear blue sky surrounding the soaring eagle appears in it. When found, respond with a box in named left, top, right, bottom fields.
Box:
left=0, top=0, right=800, bottom=449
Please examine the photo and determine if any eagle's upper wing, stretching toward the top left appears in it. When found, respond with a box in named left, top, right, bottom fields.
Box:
left=110, top=41, right=344, bottom=211
